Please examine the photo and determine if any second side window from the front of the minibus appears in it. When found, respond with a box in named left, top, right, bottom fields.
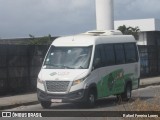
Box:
left=104, top=44, right=116, bottom=66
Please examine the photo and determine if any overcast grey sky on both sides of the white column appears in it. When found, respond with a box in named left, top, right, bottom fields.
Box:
left=0, top=0, right=160, bottom=38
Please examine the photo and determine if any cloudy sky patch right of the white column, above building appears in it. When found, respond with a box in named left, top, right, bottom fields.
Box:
left=115, top=0, right=160, bottom=19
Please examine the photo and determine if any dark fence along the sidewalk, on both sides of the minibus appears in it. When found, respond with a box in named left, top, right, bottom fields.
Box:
left=0, top=45, right=160, bottom=95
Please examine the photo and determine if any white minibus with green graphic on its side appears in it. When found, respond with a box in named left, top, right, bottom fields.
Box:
left=37, top=31, right=140, bottom=108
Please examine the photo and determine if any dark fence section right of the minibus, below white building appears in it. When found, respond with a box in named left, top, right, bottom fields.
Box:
left=138, top=45, right=160, bottom=78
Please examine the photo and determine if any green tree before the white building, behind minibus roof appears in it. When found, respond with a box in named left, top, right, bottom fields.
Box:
left=117, top=25, right=140, bottom=40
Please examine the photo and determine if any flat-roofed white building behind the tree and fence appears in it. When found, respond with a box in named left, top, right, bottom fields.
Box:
left=114, top=18, right=160, bottom=45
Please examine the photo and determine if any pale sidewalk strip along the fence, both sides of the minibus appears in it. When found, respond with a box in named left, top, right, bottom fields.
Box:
left=0, top=77, right=160, bottom=110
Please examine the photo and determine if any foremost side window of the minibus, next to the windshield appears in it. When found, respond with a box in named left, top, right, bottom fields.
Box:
left=93, top=45, right=102, bottom=69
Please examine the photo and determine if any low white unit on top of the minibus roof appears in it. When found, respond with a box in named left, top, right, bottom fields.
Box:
left=83, top=30, right=122, bottom=36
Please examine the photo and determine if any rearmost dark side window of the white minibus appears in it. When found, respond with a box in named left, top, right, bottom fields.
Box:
left=124, top=43, right=137, bottom=63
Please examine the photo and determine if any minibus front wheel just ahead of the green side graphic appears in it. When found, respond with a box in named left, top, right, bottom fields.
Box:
left=87, top=90, right=96, bottom=108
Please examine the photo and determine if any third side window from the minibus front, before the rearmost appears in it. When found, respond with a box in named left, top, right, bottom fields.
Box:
left=114, top=44, right=125, bottom=64
